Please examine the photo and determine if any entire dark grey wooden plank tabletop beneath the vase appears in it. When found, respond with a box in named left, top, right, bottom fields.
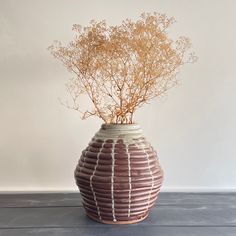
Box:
left=0, top=193, right=236, bottom=236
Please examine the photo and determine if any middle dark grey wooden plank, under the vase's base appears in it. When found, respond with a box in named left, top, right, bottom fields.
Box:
left=0, top=205, right=236, bottom=228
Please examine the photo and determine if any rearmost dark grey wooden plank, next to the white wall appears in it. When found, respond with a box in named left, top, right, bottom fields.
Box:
left=0, top=193, right=236, bottom=208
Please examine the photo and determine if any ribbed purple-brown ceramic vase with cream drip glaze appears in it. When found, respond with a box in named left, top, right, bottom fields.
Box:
left=75, top=124, right=163, bottom=224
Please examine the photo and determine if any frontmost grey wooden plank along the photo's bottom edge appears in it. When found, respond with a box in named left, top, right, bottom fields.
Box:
left=0, top=226, right=236, bottom=236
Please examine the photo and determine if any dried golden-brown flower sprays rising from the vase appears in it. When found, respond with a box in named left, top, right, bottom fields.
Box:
left=49, top=12, right=196, bottom=124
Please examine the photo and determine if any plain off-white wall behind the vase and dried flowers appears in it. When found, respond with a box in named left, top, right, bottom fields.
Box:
left=0, top=0, right=236, bottom=191
